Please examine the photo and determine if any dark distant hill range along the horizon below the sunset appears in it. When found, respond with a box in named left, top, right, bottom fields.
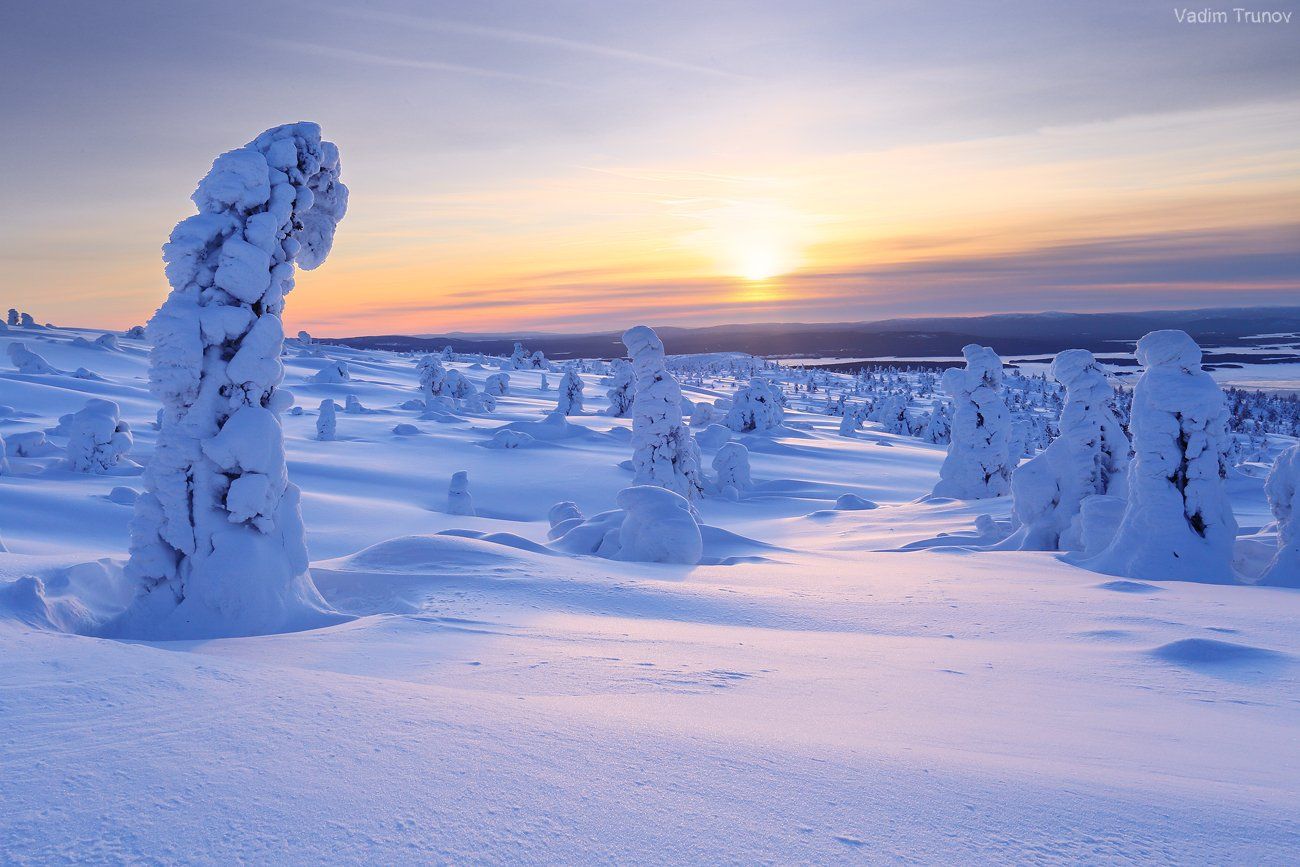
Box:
left=324, top=307, right=1300, bottom=359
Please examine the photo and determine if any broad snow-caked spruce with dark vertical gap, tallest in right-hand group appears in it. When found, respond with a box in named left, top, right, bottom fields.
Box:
left=1080, top=330, right=1236, bottom=584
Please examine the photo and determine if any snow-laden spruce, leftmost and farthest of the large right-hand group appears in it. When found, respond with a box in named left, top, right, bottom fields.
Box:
left=935, top=343, right=1013, bottom=499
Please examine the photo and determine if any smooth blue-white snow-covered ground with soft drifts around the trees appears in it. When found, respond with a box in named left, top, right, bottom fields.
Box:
left=0, top=323, right=1300, bottom=864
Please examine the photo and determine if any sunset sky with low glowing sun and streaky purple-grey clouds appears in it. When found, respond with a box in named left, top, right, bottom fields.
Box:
left=0, top=0, right=1300, bottom=337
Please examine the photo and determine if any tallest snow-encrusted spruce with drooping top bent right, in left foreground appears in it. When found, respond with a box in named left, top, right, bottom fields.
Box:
left=112, top=122, right=347, bottom=637
